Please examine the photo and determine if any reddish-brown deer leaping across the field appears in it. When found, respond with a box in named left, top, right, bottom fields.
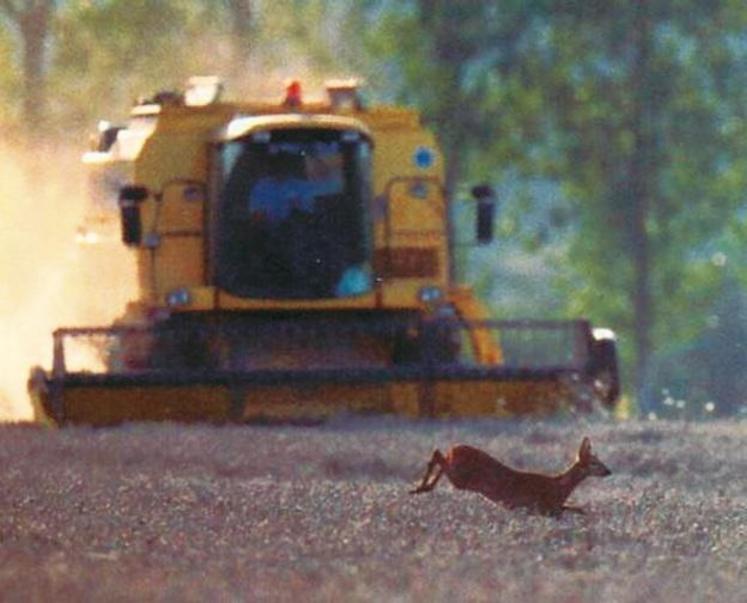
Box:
left=410, top=438, right=611, bottom=517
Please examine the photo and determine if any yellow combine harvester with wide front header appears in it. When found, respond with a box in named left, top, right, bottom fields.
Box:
left=29, top=80, right=619, bottom=425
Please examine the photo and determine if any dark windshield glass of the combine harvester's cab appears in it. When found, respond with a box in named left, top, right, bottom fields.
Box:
left=215, top=129, right=372, bottom=299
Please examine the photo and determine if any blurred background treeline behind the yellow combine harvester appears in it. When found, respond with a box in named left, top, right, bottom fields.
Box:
left=0, top=0, right=747, bottom=415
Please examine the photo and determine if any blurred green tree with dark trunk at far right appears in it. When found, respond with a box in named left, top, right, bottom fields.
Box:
left=531, top=0, right=747, bottom=391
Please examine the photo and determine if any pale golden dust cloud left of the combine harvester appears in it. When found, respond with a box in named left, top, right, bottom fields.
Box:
left=0, top=145, right=135, bottom=421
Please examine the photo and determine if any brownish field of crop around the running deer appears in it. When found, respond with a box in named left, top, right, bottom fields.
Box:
left=0, top=419, right=747, bottom=602
